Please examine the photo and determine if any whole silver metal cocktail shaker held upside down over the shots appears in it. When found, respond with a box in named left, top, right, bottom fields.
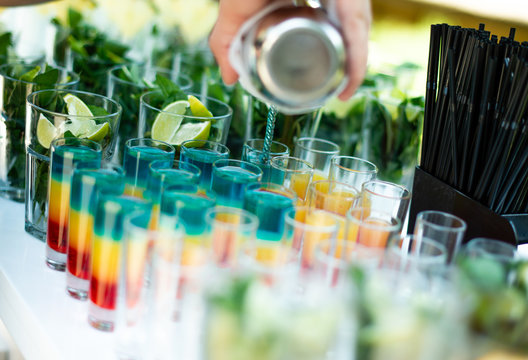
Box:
left=230, top=0, right=346, bottom=114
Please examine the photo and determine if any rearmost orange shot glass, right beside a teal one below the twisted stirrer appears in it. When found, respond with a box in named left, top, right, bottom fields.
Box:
left=269, top=156, right=314, bottom=204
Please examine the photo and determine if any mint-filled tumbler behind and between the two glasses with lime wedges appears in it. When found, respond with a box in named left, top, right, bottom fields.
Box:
left=107, top=64, right=192, bottom=164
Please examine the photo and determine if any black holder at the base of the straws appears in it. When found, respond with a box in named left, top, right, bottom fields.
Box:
left=408, top=166, right=528, bottom=245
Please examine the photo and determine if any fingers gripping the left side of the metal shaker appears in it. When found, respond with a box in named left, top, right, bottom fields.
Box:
left=209, top=0, right=270, bottom=85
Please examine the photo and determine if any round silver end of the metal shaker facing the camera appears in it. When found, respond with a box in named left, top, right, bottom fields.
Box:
left=256, top=17, right=346, bottom=107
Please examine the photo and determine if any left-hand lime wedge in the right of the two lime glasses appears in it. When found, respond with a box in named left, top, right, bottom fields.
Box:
left=151, top=100, right=189, bottom=142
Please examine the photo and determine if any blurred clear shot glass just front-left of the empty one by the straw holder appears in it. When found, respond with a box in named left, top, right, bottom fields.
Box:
left=383, top=235, right=447, bottom=276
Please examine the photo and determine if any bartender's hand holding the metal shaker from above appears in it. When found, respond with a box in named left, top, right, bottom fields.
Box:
left=209, top=0, right=372, bottom=100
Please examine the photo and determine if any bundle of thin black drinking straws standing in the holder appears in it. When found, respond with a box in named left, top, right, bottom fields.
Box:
left=420, top=24, right=528, bottom=214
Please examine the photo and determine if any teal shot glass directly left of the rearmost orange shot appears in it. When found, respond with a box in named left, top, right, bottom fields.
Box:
left=211, top=159, right=262, bottom=208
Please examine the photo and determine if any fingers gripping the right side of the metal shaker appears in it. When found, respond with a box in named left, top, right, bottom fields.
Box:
left=336, top=0, right=372, bottom=100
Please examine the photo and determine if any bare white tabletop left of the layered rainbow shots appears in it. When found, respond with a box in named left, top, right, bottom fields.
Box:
left=0, top=199, right=116, bottom=360
